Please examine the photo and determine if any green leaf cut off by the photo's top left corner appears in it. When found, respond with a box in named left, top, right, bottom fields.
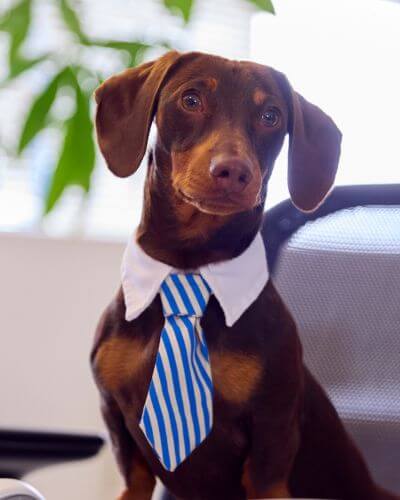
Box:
left=0, top=0, right=32, bottom=60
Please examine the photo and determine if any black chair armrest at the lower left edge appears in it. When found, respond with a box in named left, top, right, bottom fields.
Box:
left=0, top=429, right=104, bottom=478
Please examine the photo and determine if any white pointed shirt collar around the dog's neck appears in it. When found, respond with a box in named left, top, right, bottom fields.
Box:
left=121, top=233, right=269, bottom=326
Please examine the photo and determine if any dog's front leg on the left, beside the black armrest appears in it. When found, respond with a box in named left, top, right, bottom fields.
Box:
left=101, top=396, right=156, bottom=500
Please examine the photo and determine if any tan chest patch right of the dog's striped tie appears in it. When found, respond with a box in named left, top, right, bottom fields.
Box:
left=210, top=352, right=263, bottom=403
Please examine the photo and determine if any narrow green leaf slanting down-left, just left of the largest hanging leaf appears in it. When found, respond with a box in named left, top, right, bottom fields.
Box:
left=18, top=69, right=67, bottom=154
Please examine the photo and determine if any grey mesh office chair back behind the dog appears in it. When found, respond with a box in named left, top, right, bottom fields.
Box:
left=264, top=185, right=400, bottom=493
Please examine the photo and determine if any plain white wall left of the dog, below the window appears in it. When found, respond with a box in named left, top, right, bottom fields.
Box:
left=0, top=234, right=123, bottom=500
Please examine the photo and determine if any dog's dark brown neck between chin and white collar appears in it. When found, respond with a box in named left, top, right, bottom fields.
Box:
left=137, top=148, right=263, bottom=269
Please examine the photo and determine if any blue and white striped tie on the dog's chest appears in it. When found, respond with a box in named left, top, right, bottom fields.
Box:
left=139, top=274, right=213, bottom=471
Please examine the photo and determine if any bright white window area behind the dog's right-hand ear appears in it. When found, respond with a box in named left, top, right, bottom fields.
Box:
left=251, top=0, right=400, bottom=206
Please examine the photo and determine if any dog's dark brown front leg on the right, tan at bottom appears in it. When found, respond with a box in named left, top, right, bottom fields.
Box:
left=243, top=343, right=304, bottom=498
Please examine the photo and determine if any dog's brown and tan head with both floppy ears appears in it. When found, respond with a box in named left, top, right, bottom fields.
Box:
left=96, top=52, right=341, bottom=215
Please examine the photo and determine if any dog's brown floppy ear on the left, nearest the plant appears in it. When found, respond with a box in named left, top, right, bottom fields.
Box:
left=95, top=51, right=179, bottom=177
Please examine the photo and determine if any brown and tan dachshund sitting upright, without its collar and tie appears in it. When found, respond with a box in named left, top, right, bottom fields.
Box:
left=92, top=52, right=396, bottom=500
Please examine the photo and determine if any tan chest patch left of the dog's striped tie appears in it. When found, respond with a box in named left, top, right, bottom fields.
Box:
left=94, top=336, right=153, bottom=391
